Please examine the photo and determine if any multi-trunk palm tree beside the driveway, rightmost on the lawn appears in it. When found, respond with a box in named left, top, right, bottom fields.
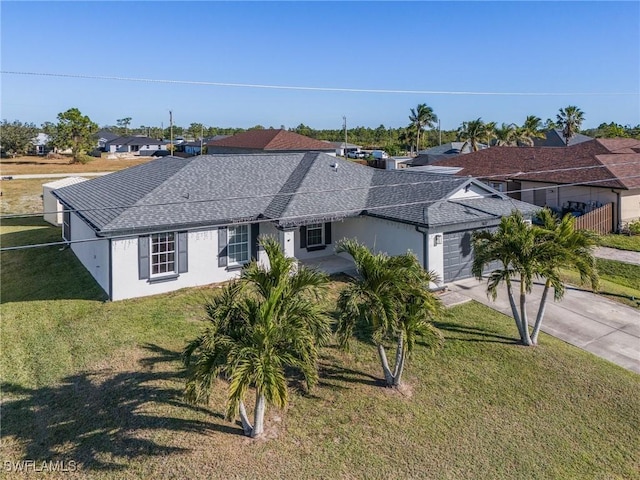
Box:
left=472, top=211, right=597, bottom=346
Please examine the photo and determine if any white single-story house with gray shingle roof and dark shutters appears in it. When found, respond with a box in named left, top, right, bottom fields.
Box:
left=54, top=153, right=535, bottom=300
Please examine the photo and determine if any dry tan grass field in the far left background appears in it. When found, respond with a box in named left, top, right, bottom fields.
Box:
left=0, top=156, right=153, bottom=176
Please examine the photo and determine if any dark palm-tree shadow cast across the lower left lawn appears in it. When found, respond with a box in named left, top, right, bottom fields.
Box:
left=0, top=345, right=242, bottom=471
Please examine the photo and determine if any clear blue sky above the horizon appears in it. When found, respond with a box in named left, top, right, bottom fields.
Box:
left=0, top=1, right=640, bottom=129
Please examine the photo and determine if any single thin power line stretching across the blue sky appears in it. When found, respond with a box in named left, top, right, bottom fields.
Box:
left=0, top=70, right=640, bottom=97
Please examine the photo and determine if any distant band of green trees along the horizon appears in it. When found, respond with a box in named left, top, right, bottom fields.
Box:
left=0, top=103, right=640, bottom=158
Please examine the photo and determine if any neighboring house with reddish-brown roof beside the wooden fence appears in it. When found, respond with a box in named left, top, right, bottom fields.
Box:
left=433, top=138, right=640, bottom=229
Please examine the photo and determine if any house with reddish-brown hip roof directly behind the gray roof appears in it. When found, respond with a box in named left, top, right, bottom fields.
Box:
left=207, top=128, right=336, bottom=156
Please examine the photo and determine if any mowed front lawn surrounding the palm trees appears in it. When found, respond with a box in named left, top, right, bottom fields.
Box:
left=0, top=225, right=640, bottom=479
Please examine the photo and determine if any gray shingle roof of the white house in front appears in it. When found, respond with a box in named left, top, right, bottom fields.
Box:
left=54, top=153, right=527, bottom=236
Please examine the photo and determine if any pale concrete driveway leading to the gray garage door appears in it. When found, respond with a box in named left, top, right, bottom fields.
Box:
left=443, top=278, right=640, bottom=373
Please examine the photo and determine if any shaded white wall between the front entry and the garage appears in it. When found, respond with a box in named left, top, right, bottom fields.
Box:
left=333, top=217, right=424, bottom=265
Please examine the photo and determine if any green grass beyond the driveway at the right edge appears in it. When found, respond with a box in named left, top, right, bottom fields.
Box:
left=562, top=258, right=640, bottom=309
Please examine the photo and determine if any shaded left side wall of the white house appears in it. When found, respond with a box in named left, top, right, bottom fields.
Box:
left=70, top=213, right=110, bottom=293
